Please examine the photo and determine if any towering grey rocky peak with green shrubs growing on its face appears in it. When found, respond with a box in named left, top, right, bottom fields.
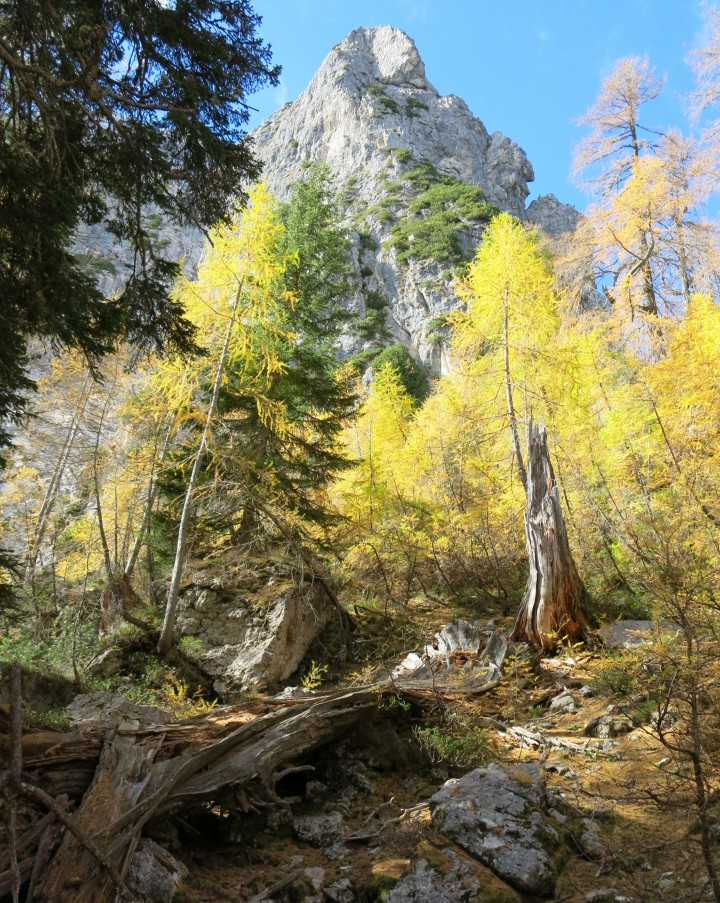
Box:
left=253, top=26, right=577, bottom=372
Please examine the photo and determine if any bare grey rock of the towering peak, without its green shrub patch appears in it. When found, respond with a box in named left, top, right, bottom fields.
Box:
left=253, top=26, right=548, bottom=372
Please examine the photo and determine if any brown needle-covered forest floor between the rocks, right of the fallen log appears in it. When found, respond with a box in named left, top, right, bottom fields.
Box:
left=169, top=606, right=712, bottom=903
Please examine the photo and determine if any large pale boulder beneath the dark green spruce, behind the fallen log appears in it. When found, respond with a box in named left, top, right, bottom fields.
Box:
left=176, top=572, right=333, bottom=696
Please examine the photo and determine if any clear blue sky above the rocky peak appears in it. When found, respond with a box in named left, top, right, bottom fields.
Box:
left=249, top=0, right=702, bottom=209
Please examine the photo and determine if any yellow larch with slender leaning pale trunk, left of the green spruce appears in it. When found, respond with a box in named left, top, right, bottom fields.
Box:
left=156, top=185, right=293, bottom=654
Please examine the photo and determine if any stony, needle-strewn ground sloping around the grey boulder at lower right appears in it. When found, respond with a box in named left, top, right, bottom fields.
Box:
left=156, top=608, right=712, bottom=903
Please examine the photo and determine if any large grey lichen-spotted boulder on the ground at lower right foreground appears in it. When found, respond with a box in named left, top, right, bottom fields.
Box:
left=430, top=764, right=562, bottom=896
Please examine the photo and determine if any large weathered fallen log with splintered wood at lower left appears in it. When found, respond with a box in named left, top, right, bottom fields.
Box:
left=0, top=661, right=500, bottom=903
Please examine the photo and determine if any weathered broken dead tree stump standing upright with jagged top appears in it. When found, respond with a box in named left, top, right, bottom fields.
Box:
left=510, top=420, right=588, bottom=650
